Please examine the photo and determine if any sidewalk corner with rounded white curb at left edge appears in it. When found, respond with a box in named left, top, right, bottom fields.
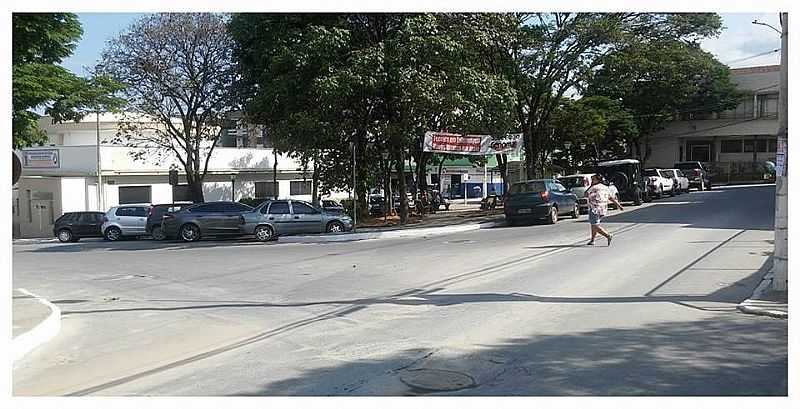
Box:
left=11, top=288, right=61, bottom=361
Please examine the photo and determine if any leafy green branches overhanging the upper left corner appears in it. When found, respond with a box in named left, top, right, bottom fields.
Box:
left=12, top=13, right=121, bottom=149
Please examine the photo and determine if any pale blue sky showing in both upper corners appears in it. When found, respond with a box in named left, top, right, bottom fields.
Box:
left=62, top=13, right=781, bottom=75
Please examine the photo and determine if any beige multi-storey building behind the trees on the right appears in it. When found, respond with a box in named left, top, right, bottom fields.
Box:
left=646, top=65, right=780, bottom=183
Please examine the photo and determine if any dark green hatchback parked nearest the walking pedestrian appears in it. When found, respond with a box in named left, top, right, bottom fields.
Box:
left=503, top=179, right=579, bottom=226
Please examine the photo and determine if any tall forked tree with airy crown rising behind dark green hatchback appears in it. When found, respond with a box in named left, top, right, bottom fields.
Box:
left=478, top=13, right=721, bottom=178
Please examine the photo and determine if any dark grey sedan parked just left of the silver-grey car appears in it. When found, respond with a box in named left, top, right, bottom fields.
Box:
left=161, top=202, right=253, bottom=242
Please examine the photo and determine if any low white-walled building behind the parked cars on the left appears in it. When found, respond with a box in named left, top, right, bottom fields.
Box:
left=12, top=114, right=346, bottom=237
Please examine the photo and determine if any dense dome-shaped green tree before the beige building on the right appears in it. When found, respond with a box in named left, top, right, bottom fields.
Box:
left=587, top=40, right=740, bottom=161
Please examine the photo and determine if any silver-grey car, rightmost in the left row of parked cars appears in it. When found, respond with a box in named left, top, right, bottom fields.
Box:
left=241, top=200, right=353, bottom=241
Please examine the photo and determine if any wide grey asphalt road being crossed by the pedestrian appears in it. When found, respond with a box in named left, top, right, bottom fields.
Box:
left=13, top=185, right=788, bottom=396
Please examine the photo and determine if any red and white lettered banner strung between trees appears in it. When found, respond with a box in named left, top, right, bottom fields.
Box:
left=422, top=132, right=522, bottom=156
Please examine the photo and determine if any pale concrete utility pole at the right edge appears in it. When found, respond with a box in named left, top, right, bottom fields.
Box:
left=772, top=13, right=789, bottom=291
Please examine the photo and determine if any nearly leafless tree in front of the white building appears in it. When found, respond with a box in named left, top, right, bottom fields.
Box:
left=98, top=13, right=239, bottom=202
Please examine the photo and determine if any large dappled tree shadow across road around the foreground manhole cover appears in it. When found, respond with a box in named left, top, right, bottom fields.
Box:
left=230, top=314, right=788, bottom=396
